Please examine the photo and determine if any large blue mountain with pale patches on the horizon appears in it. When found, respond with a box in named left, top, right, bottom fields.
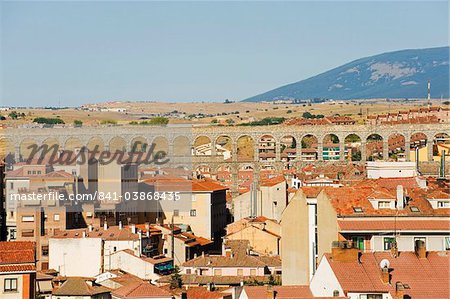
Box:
left=244, top=47, right=450, bottom=102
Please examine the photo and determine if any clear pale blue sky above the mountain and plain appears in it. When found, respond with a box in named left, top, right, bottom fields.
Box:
left=0, top=1, right=449, bottom=106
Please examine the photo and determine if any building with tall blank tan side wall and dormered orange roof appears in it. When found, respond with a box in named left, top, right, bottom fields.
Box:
left=281, top=177, right=450, bottom=285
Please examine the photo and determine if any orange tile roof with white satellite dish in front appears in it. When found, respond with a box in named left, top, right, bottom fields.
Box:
left=324, top=252, right=450, bottom=298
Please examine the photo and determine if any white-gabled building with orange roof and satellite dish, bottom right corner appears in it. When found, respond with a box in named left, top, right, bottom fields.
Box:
left=310, top=240, right=450, bottom=299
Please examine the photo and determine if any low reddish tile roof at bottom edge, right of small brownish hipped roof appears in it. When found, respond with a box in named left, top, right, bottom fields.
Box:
left=112, top=282, right=172, bottom=299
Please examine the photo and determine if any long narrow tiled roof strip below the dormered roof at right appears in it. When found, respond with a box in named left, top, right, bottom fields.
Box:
left=338, top=219, right=450, bottom=232
